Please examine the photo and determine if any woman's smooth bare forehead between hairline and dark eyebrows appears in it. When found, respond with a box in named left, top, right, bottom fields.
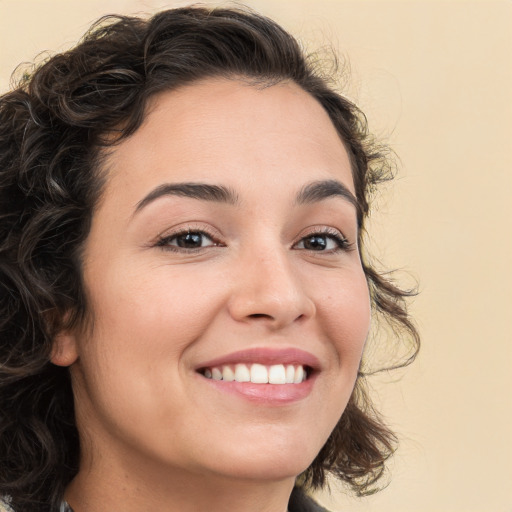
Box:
left=100, top=79, right=354, bottom=208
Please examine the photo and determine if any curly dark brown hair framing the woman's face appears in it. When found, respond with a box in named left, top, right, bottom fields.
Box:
left=0, top=7, right=419, bottom=512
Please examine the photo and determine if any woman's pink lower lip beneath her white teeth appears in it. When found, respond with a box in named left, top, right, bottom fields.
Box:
left=199, top=375, right=316, bottom=406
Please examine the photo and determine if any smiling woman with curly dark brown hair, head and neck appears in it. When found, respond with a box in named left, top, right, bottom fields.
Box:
left=0, top=7, right=418, bottom=512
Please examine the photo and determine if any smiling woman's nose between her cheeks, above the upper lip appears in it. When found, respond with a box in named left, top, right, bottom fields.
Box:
left=228, top=250, right=315, bottom=329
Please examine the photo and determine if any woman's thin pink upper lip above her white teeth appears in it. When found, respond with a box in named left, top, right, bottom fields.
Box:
left=196, top=347, right=320, bottom=370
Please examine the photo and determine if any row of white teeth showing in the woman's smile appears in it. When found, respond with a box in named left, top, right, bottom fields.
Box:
left=198, top=363, right=312, bottom=384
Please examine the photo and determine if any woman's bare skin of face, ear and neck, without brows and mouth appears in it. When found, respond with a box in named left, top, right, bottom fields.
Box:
left=53, top=79, right=370, bottom=512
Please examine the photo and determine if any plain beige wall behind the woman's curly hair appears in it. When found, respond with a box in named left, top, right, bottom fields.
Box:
left=0, top=0, right=512, bottom=512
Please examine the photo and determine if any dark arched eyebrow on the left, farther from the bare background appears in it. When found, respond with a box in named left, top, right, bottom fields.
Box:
left=135, top=183, right=238, bottom=213
